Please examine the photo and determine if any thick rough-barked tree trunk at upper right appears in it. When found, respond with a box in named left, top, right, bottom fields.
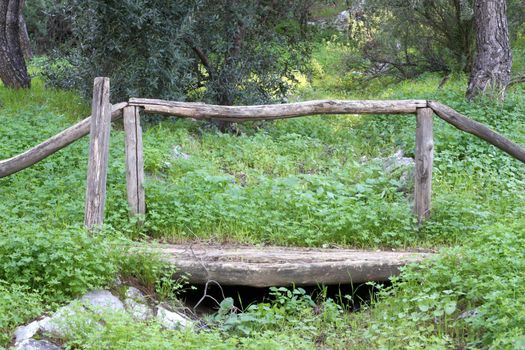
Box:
left=466, top=0, right=512, bottom=100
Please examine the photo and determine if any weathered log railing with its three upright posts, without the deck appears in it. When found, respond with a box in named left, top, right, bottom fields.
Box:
left=0, top=78, right=525, bottom=228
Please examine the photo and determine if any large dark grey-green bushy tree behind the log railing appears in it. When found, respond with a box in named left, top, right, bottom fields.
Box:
left=42, top=0, right=310, bottom=117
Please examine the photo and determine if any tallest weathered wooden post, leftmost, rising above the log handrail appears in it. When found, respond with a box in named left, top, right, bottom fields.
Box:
left=84, top=77, right=111, bottom=229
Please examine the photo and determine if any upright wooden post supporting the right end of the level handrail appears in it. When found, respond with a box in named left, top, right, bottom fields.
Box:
left=414, top=108, right=434, bottom=224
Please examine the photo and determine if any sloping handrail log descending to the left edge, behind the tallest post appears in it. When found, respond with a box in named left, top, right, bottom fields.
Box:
left=0, top=102, right=128, bottom=178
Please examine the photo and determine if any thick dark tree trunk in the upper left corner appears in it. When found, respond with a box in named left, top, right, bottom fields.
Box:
left=0, top=0, right=31, bottom=89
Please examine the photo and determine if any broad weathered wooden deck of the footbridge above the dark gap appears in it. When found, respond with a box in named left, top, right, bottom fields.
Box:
left=147, top=244, right=432, bottom=287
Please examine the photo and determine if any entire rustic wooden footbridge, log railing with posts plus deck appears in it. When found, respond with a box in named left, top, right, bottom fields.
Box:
left=0, top=78, right=525, bottom=286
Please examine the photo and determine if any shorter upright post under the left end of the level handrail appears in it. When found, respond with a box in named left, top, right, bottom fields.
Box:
left=124, top=107, right=146, bottom=215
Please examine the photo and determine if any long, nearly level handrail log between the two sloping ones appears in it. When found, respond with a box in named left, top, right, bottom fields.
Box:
left=129, top=98, right=427, bottom=122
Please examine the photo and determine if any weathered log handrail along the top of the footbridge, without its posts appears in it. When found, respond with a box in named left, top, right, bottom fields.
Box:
left=0, top=98, right=525, bottom=182
